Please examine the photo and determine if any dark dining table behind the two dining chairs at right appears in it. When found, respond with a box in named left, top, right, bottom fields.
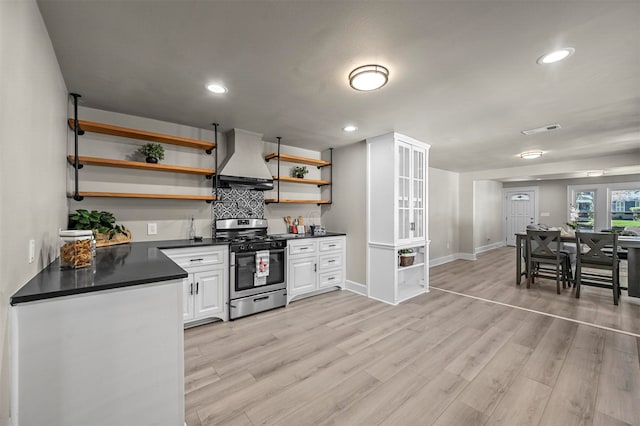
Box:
left=515, top=232, right=640, bottom=297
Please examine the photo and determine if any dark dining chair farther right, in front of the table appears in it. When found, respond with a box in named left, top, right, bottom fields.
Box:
left=576, top=231, right=621, bottom=305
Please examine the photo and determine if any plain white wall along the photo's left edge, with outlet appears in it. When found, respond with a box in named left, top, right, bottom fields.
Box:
left=0, top=0, right=67, bottom=425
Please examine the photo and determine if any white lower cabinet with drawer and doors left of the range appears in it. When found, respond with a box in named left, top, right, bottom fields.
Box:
left=162, top=246, right=229, bottom=324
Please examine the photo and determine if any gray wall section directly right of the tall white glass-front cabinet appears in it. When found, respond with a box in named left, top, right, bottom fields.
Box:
left=429, top=167, right=460, bottom=260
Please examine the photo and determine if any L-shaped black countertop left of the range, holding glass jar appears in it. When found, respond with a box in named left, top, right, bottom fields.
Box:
left=10, top=238, right=226, bottom=305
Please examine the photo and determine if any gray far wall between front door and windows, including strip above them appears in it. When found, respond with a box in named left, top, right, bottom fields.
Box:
left=502, top=174, right=640, bottom=226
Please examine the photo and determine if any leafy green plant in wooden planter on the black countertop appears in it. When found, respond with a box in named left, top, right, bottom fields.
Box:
left=68, top=209, right=131, bottom=246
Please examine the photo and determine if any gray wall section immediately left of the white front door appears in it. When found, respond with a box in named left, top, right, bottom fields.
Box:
left=473, top=180, right=504, bottom=252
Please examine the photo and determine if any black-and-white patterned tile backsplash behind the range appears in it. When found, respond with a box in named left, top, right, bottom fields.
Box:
left=213, top=188, right=264, bottom=220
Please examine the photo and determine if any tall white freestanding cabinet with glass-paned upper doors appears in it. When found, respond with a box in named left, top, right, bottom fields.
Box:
left=367, top=133, right=429, bottom=304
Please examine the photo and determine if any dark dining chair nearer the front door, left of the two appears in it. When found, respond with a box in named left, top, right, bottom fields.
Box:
left=526, top=229, right=568, bottom=294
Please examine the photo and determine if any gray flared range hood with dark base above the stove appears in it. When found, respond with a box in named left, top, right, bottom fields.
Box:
left=217, top=129, right=273, bottom=191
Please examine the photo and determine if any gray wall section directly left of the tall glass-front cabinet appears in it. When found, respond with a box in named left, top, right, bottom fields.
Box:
left=322, top=141, right=367, bottom=285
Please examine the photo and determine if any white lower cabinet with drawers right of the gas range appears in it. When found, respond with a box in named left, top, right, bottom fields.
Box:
left=287, top=236, right=346, bottom=303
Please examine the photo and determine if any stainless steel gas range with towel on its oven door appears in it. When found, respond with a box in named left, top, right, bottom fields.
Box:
left=215, top=219, right=287, bottom=320
